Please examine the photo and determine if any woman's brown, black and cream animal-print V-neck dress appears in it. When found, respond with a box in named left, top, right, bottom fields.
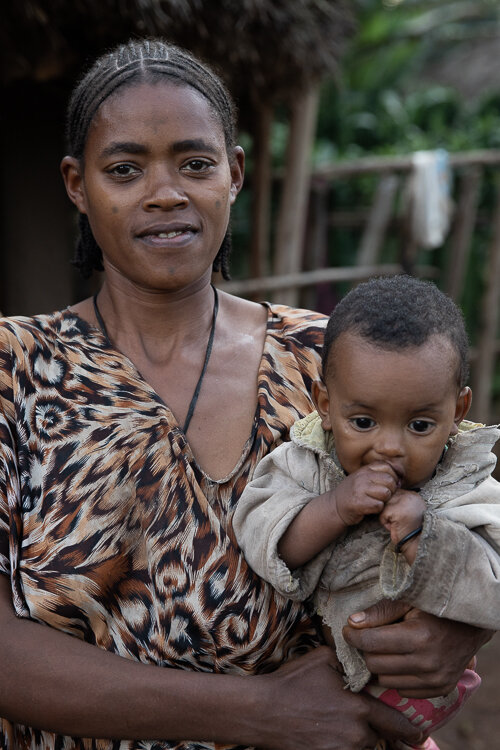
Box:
left=0, top=306, right=326, bottom=750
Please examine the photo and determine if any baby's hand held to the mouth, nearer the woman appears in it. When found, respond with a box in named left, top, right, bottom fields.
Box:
left=335, top=461, right=398, bottom=526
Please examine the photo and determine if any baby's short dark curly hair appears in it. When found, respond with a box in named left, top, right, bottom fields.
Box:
left=322, top=275, right=469, bottom=389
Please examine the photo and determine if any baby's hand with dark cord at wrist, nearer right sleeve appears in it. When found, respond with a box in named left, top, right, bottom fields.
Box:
left=380, top=490, right=425, bottom=564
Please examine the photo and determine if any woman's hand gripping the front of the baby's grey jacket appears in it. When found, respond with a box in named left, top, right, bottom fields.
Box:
left=343, top=600, right=493, bottom=698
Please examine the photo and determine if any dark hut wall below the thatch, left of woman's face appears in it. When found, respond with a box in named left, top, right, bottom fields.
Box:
left=0, top=81, right=75, bottom=314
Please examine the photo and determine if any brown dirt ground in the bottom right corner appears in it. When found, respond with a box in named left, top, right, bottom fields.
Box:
left=432, top=633, right=500, bottom=750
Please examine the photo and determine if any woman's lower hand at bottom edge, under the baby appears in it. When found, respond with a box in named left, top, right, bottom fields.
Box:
left=252, top=646, right=421, bottom=750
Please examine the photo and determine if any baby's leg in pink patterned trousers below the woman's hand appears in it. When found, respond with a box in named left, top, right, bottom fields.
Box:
left=365, top=669, right=481, bottom=750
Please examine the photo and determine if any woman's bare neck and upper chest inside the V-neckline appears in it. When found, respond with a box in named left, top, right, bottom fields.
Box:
left=73, top=279, right=268, bottom=478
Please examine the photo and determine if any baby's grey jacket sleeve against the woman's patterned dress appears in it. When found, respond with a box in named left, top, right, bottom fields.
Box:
left=233, top=442, right=333, bottom=601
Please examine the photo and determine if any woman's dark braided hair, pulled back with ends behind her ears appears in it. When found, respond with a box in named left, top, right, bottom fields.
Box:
left=66, top=39, right=236, bottom=279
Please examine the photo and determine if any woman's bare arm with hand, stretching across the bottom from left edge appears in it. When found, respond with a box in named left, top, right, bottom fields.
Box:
left=0, top=575, right=418, bottom=750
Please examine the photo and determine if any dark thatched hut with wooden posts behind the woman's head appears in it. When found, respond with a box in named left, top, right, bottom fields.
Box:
left=0, top=0, right=353, bottom=314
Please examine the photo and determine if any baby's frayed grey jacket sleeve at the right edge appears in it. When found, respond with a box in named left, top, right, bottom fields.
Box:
left=380, top=477, right=500, bottom=630
